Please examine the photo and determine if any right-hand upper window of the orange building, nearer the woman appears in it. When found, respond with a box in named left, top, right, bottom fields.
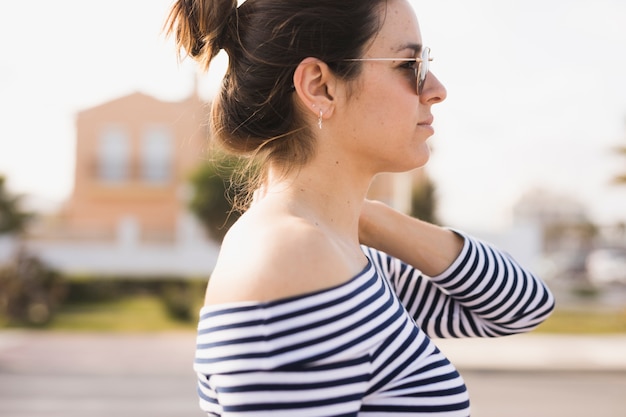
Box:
left=141, top=125, right=173, bottom=184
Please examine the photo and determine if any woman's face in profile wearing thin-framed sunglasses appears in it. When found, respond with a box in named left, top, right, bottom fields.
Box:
left=336, top=0, right=446, bottom=173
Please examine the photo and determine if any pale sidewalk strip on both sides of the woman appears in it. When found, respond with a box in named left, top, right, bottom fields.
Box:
left=0, top=331, right=626, bottom=375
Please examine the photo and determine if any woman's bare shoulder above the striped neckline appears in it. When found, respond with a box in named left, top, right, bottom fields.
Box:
left=205, top=202, right=358, bottom=304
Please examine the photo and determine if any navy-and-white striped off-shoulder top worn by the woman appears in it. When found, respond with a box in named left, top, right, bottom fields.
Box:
left=194, top=232, right=554, bottom=417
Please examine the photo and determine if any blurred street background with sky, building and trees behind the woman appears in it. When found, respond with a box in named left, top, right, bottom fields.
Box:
left=0, top=0, right=626, bottom=417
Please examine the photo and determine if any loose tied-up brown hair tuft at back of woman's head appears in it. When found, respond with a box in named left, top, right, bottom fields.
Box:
left=165, top=0, right=237, bottom=70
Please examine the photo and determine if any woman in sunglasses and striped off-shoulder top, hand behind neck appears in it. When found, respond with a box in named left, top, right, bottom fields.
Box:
left=168, top=0, right=553, bottom=417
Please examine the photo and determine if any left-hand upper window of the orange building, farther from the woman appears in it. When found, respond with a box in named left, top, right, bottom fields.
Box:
left=98, top=126, right=130, bottom=183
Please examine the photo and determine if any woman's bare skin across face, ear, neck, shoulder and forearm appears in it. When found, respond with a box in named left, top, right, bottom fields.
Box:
left=206, top=0, right=463, bottom=305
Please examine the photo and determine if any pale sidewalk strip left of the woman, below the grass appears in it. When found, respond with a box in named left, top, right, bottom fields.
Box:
left=0, top=331, right=195, bottom=376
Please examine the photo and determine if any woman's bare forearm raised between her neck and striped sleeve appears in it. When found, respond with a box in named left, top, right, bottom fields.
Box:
left=359, top=200, right=464, bottom=276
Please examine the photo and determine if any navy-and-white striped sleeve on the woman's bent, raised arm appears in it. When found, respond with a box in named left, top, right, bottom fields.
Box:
left=367, top=234, right=554, bottom=338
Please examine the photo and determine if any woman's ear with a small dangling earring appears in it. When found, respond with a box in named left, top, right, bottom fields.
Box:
left=293, top=58, right=337, bottom=118
